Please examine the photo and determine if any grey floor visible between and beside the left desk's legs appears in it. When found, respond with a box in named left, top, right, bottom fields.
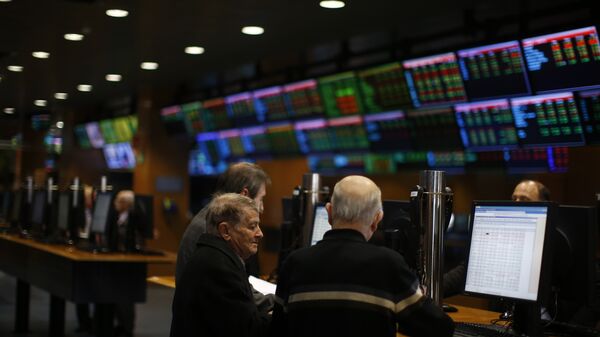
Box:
left=0, top=272, right=175, bottom=337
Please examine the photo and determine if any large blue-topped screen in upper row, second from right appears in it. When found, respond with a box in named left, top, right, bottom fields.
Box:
left=457, top=41, right=531, bottom=100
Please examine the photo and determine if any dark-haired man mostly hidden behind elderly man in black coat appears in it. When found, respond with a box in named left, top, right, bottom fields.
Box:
left=175, top=162, right=274, bottom=312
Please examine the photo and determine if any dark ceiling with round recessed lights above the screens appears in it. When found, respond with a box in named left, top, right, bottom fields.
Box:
left=0, top=0, right=598, bottom=123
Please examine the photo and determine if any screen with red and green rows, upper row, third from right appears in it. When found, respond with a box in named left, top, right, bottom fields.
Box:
left=402, top=53, right=467, bottom=107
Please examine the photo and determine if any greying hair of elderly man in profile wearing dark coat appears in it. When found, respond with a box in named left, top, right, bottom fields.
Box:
left=206, top=193, right=258, bottom=234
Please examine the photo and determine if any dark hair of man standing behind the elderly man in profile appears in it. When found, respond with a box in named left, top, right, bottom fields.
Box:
left=215, top=162, right=271, bottom=199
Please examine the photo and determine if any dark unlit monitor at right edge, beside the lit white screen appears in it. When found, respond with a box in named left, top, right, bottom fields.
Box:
left=551, top=205, right=598, bottom=324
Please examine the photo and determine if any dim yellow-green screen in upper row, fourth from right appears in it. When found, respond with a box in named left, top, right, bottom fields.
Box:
left=358, top=62, right=412, bottom=113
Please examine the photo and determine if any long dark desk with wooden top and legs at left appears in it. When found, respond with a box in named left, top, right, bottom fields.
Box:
left=0, top=234, right=176, bottom=337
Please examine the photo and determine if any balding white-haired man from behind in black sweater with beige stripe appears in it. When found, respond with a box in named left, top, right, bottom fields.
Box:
left=272, top=176, right=454, bottom=337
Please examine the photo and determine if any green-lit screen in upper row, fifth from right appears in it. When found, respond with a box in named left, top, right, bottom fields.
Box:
left=319, top=71, right=363, bottom=118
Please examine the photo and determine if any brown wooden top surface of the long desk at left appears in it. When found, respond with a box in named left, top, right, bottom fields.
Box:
left=0, top=234, right=177, bottom=263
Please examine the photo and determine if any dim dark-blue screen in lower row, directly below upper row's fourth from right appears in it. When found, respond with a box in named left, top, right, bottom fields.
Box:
left=363, top=111, right=411, bottom=152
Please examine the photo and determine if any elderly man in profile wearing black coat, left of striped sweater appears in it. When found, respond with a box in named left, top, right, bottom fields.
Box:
left=171, top=193, right=270, bottom=337
